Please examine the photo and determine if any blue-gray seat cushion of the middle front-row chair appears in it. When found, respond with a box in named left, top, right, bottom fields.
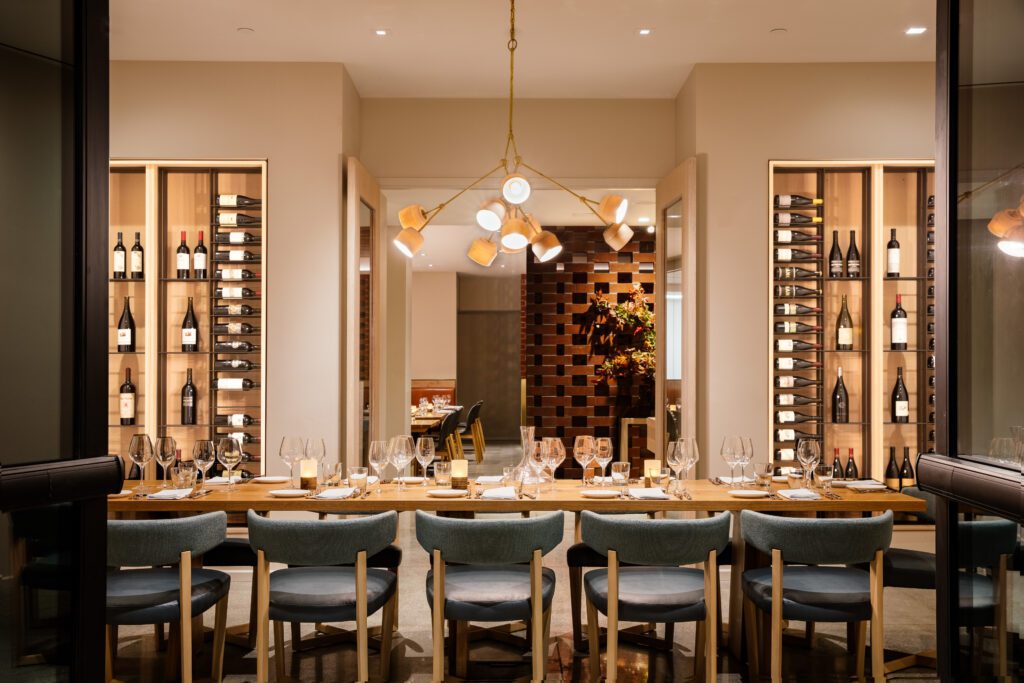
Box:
left=427, top=564, right=555, bottom=622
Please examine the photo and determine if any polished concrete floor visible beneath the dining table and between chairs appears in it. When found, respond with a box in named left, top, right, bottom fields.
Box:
left=103, top=444, right=935, bottom=683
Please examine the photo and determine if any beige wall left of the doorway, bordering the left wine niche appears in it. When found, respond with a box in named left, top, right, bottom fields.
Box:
left=111, top=61, right=359, bottom=472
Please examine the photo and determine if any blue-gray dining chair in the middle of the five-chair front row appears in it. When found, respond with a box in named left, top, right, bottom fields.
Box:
left=416, top=511, right=565, bottom=681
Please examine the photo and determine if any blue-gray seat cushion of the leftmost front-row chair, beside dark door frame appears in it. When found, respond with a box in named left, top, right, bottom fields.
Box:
left=106, top=567, right=231, bottom=625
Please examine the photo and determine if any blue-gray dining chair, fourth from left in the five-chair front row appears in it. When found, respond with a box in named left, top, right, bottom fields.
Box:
left=581, top=511, right=732, bottom=681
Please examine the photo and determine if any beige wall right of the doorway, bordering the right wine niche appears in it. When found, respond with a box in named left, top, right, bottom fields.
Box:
left=676, top=63, right=935, bottom=474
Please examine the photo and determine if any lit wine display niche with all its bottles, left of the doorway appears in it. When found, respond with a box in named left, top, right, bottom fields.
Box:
left=108, top=160, right=269, bottom=475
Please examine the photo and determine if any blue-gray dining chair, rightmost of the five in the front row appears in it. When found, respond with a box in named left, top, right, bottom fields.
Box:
left=740, top=510, right=893, bottom=683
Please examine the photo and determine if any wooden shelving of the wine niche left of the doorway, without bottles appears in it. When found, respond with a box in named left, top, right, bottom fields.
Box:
left=109, top=160, right=268, bottom=474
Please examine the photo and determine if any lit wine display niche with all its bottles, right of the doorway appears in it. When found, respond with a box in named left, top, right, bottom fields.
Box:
left=767, top=161, right=936, bottom=483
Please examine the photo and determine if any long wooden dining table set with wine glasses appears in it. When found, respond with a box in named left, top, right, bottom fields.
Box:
left=108, top=479, right=926, bottom=657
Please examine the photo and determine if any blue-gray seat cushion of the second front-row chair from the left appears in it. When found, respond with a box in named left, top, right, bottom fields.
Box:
left=270, top=566, right=395, bottom=624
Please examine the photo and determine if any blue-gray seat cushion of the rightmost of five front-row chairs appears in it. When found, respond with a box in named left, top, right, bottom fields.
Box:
left=743, top=565, right=871, bottom=622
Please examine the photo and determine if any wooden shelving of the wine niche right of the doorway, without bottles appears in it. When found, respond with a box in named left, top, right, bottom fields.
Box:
left=768, top=161, right=935, bottom=480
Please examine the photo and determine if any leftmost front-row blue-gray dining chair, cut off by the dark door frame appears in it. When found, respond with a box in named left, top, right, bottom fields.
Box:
left=106, top=512, right=231, bottom=683
